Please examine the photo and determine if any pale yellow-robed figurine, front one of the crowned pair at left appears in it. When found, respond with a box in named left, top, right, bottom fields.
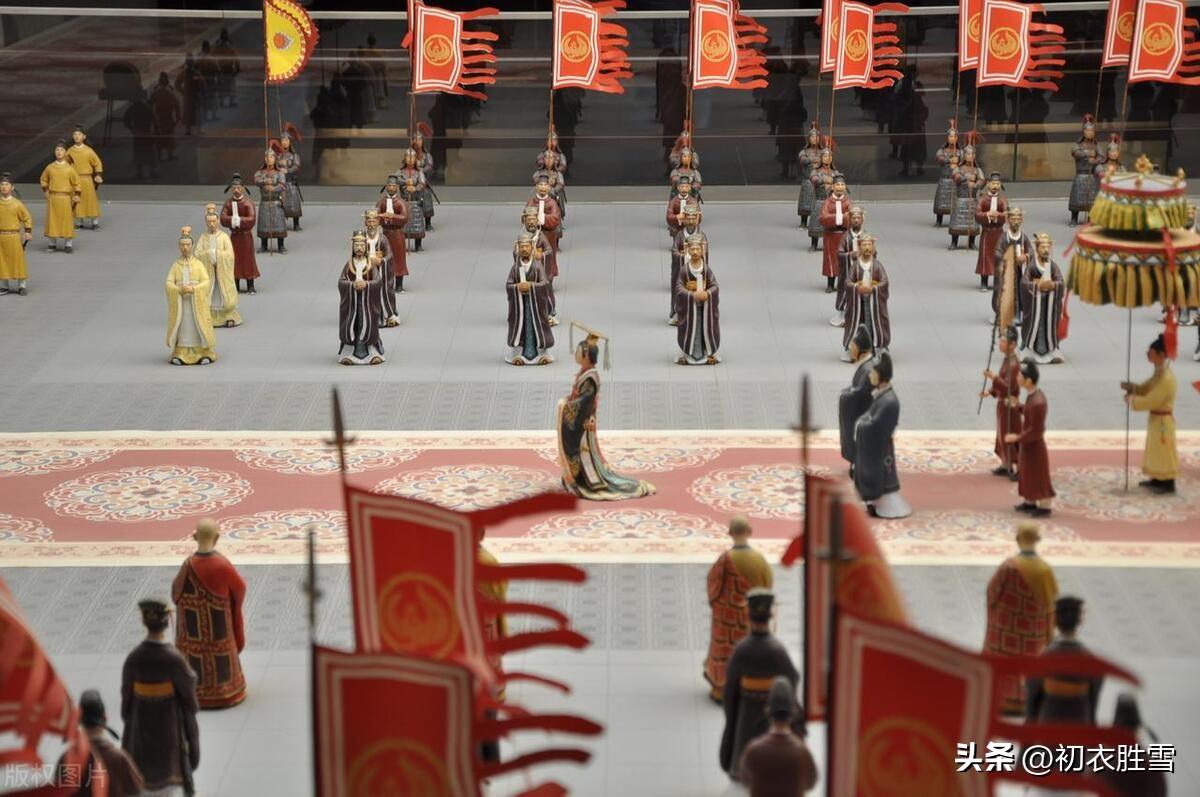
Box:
left=167, top=227, right=217, bottom=365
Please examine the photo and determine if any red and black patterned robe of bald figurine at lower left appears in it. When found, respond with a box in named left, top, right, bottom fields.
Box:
left=170, top=551, right=246, bottom=708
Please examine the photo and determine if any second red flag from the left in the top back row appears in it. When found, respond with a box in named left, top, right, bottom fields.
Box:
left=553, top=0, right=634, bottom=94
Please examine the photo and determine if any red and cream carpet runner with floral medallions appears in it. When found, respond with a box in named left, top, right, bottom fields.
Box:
left=0, top=430, right=1200, bottom=567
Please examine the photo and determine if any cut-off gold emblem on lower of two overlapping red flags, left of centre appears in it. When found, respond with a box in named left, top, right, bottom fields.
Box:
left=347, top=738, right=455, bottom=797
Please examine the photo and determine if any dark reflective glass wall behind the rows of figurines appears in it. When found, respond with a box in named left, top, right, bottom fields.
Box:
left=0, top=0, right=1200, bottom=186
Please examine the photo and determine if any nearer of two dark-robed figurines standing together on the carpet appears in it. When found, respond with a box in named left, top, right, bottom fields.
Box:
left=854, top=354, right=912, bottom=517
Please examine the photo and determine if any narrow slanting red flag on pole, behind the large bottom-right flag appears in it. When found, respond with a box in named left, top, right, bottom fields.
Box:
left=782, top=474, right=906, bottom=720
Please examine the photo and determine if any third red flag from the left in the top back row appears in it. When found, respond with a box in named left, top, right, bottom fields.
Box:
left=688, top=0, right=767, bottom=89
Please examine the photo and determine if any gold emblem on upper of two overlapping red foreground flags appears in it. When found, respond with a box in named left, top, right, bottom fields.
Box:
left=378, top=573, right=458, bottom=657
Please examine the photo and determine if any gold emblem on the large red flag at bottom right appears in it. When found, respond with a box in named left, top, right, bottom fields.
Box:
left=858, top=717, right=961, bottom=797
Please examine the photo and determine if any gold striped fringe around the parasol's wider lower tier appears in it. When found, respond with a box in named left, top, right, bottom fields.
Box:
left=1067, top=248, right=1200, bottom=307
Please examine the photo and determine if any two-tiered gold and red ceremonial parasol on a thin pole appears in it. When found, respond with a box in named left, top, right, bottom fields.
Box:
left=1067, top=155, right=1200, bottom=490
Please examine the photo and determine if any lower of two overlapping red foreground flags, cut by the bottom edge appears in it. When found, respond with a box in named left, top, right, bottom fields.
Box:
left=313, top=646, right=602, bottom=797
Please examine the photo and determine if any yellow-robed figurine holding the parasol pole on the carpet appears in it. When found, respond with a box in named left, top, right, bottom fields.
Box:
left=1121, top=335, right=1180, bottom=495
